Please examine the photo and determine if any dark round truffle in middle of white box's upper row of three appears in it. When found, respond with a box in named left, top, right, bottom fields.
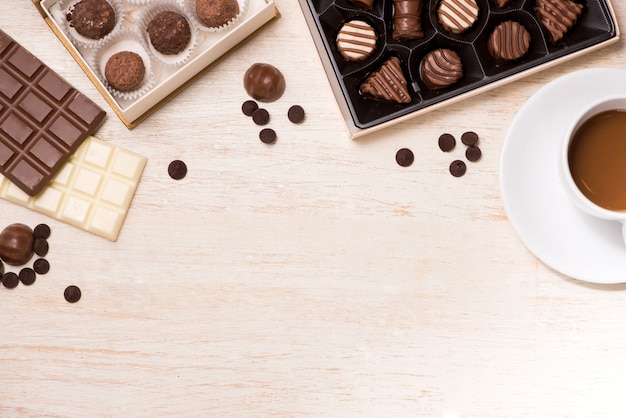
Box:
left=146, top=11, right=191, bottom=55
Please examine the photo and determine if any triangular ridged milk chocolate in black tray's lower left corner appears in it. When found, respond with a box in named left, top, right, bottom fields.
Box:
left=359, top=57, right=411, bottom=103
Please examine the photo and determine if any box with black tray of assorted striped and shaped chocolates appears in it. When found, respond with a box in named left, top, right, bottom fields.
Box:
left=299, top=0, right=619, bottom=138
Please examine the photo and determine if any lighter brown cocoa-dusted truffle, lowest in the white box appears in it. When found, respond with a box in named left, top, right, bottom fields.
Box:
left=104, top=51, right=146, bottom=92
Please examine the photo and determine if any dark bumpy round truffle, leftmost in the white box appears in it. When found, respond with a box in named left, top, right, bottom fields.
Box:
left=67, top=0, right=115, bottom=39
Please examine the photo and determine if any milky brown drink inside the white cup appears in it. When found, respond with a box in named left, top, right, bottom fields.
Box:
left=568, top=110, right=626, bottom=211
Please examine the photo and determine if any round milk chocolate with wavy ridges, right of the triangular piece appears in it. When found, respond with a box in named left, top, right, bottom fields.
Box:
left=420, top=48, right=463, bottom=89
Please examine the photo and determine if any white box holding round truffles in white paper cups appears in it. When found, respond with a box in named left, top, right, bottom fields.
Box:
left=33, top=0, right=278, bottom=128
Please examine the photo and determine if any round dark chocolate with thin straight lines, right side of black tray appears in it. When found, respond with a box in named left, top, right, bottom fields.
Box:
left=487, top=20, right=530, bottom=62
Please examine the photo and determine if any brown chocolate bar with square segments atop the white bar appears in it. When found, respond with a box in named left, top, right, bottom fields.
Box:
left=0, top=30, right=105, bottom=196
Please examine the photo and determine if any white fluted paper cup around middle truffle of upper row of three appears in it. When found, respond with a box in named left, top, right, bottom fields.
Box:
left=138, top=0, right=199, bottom=66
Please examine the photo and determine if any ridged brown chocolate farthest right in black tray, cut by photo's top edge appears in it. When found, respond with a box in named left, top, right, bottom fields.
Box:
left=535, top=0, right=583, bottom=44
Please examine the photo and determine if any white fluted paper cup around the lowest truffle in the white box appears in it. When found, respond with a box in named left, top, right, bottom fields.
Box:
left=90, top=28, right=154, bottom=100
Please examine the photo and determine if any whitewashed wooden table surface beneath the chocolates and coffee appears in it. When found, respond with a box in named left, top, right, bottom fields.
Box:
left=0, top=0, right=626, bottom=418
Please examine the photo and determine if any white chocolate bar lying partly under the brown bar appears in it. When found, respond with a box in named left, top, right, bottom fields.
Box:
left=0, top=136, right=147, bottom=241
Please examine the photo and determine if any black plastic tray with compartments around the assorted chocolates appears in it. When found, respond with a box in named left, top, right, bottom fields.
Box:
left=301, top=0, right=618, bottom=129
